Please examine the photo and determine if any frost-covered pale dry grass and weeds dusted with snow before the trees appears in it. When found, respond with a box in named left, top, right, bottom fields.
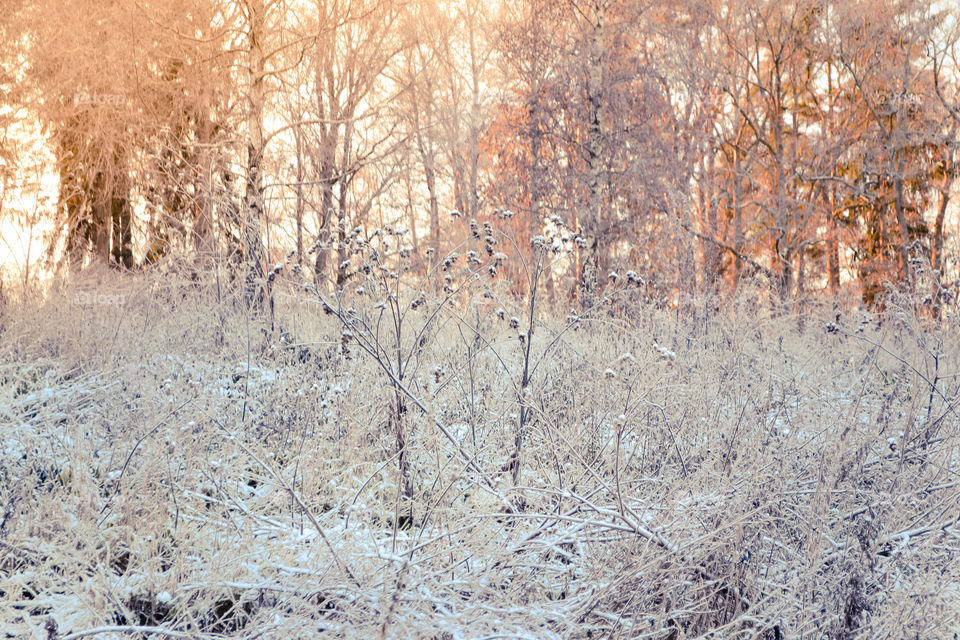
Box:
left=0, top=278, right=960, bottom=640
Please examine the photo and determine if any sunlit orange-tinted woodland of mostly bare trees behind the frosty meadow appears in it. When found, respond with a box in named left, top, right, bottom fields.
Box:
left=0, top=0, right=960, bottom=315
